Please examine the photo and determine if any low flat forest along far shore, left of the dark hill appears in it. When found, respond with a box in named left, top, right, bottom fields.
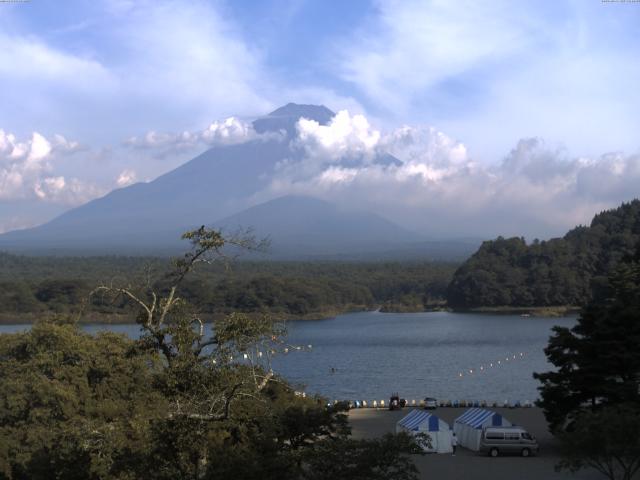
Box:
left=0, top=253, right=457, bottom=322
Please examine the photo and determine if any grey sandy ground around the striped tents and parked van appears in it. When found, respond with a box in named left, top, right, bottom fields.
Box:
left=349, top=408, right=602, bottom=480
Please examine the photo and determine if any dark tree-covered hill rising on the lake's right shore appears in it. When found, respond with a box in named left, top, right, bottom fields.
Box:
left=447, top=200, right=640, bottom=308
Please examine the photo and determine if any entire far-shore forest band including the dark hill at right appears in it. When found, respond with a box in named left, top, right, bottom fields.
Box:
left=5, top=200, right=640, bottom=322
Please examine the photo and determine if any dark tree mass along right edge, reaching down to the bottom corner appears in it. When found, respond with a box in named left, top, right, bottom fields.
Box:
left=534, top=244, right=640, bottom=480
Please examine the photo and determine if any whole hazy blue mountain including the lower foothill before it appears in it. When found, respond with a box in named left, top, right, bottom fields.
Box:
left=0, top=103, right=471, bottom=259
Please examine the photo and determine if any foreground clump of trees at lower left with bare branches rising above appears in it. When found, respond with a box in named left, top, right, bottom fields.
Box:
left=0, top=227, right=424, bottom=480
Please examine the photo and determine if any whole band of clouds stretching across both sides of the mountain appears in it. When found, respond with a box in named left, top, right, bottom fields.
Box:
left=0, top=106, right=640, bottom=238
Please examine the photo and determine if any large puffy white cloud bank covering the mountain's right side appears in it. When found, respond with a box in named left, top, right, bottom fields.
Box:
left=254, top=112, right=640, bottom=237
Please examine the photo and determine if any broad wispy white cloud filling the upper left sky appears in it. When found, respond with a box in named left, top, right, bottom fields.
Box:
left=0, top=0, right=273, bottom=144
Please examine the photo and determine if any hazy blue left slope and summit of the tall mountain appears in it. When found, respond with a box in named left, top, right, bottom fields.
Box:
left=0, top=104, right=333, bottom=250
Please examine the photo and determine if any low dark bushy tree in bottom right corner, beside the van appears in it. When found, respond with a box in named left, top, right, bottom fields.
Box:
left=558, top=405, right=640, bottom=480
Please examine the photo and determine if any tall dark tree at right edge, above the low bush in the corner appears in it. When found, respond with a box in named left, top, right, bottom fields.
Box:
left=534, top=244, right=640, bottom=431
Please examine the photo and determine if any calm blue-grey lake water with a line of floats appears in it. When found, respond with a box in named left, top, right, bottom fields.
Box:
left=0, top=312, right=575, bottom=402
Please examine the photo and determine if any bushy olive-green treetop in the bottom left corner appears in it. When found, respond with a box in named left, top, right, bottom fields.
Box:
left=0, top=322, right=167, bottom=480
